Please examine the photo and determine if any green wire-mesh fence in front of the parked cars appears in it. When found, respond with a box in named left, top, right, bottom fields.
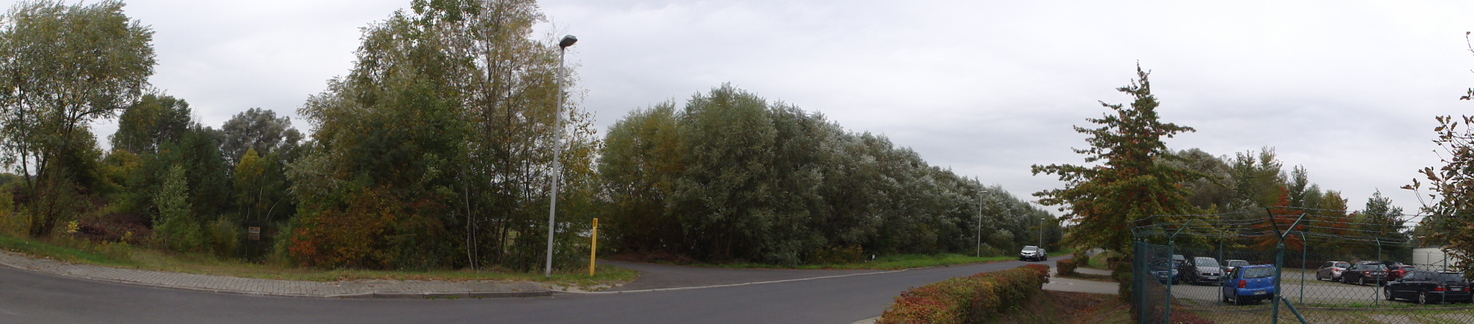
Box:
left=1131, top=208, right=1474, bottom=324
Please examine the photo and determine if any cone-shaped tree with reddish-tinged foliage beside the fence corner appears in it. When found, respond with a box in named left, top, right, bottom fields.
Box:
left=1033, top=66, right=1204, bottom=296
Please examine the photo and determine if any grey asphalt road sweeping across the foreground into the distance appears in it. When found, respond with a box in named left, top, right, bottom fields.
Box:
left=0, top=256, right=1054, bottom=324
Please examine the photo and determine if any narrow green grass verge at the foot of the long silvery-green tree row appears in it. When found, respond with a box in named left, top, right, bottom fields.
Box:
left=649, top=250, right=1070, bottom=270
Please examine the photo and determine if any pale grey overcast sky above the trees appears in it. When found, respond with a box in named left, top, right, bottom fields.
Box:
left=40, top=0, right=1474, bottom=220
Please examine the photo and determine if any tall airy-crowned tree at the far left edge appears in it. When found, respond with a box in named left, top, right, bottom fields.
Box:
left=0, top=1, right=155, bottom=236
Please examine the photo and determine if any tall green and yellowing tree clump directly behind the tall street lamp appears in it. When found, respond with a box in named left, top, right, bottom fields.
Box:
left=286, top=0, right=597, bottom=270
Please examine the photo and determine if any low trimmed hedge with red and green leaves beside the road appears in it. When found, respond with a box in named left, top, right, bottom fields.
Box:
left=876, top=264, right=1049, bottom=324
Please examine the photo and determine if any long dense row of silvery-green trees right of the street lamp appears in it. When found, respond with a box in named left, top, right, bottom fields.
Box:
left=598, top=85, right=1060, bottom=264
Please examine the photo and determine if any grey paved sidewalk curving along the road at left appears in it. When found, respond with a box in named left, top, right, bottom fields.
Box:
left=0, top=250, right=553, bottom=297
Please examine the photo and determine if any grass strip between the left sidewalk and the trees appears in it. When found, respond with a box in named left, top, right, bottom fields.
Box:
left=0, top=234, right=637, bottom=287
